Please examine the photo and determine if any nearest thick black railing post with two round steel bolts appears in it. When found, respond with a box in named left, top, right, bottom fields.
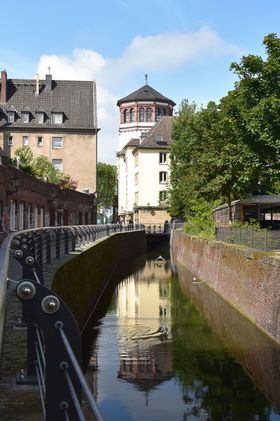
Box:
left=16, top=280, right=81, bottom=421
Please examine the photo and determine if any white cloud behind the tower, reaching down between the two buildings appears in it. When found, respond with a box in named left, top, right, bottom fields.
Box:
left=38, top=27, right=241, bottom=163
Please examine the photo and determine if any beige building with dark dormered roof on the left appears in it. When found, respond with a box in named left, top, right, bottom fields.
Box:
left=0, top=71, right=98, bottom=193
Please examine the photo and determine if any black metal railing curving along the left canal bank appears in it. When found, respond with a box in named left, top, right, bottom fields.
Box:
left=0, top=224, right=143, bottom=421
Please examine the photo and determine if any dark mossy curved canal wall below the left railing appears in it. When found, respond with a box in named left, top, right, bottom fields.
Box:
left=52, top=231, right=146, bottom=329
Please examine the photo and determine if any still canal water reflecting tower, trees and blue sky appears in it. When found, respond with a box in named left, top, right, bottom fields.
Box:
left=85, top=246, right=280, bottom=421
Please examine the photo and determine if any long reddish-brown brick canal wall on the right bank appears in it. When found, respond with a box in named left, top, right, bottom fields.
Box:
left=172, top=230, right=280, bottom=344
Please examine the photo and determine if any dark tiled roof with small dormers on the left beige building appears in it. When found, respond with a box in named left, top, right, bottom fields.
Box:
left=0, top=79, right=98, bottom=130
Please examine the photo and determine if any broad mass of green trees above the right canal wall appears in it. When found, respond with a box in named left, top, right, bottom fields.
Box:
left=169, top=34, right=280, bottom=231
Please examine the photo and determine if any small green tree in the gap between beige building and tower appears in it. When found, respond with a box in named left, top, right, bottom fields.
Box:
left=97, top=162, right=117, bottom=208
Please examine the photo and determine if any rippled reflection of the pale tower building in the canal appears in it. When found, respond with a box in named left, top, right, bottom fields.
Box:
left=117, top=261, right=172, bottom=390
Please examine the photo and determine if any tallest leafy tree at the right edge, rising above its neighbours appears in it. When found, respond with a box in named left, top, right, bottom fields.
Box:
left=231, top=33, right=280, bottom=190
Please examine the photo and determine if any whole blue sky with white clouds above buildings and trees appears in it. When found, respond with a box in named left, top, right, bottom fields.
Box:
left=0, top=0, right=280, bottom=164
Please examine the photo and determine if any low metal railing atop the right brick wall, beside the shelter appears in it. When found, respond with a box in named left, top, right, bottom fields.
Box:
left=216, top=226, right=280, bottom=251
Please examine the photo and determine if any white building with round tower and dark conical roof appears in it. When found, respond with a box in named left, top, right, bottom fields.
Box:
left=117, top=85, right=175, bottom=224
